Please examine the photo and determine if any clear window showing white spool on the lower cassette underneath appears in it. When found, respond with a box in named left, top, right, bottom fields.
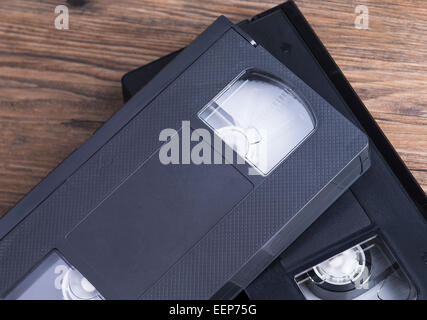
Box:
left=295, top=237, right=417, bottom=300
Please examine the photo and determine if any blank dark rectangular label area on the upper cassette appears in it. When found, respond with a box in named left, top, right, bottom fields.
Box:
left=67, top=146, right=252, bottom=299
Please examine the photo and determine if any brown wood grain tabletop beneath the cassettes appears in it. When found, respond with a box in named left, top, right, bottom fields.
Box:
left=0, top=0, right=427, bottom=216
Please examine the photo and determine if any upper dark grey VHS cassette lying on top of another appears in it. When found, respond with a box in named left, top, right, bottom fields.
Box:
left=0, top=17, right=370, bottom=299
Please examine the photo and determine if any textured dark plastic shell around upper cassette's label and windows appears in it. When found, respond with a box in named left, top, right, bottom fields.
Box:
left=0, top=15, right=368, bottom=299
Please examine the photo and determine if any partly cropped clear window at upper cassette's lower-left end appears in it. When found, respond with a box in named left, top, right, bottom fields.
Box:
left=5, top=251, right=103, bottom=300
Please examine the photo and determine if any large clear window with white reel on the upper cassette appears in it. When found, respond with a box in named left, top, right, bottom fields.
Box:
left=199, top=70, right=315, bottom=175
